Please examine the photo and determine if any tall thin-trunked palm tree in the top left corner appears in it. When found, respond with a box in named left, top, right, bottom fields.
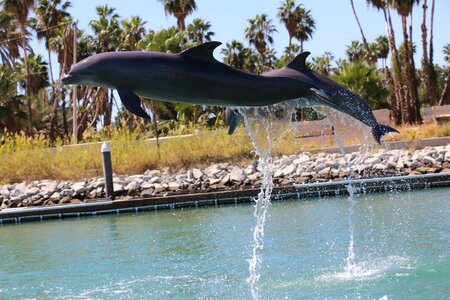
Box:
left=1, top=0, right=34, bottom=134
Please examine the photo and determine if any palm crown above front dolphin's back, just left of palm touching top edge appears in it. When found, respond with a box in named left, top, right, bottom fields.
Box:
left=120, top=16, right=147, bottom=51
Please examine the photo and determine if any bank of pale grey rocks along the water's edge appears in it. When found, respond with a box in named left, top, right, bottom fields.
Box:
left=0, top=145, right=450, bottom=209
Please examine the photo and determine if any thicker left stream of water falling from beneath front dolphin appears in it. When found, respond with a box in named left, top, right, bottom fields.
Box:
left=236, top=103, right=294, bottom=299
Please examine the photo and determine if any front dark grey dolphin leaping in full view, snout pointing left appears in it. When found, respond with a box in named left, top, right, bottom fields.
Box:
left=62, top=42, right=318, bottom=119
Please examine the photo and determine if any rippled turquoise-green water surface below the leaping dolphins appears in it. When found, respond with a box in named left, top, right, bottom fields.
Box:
left=0, top=189, right=450, bottom=299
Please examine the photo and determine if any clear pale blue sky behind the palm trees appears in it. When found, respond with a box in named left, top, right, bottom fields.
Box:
left=30, top=0, right=450, bottom=65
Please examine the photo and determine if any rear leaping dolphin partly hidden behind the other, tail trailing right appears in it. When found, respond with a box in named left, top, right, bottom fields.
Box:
left=225, top=51, right=398, bottom=144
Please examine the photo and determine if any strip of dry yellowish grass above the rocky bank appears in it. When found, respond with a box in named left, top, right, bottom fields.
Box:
left=0, top=120, right=450, bottom=184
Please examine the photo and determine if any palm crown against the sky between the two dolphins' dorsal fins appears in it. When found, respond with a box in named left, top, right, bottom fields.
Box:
left=245, top=14, right=277, bottom=61
